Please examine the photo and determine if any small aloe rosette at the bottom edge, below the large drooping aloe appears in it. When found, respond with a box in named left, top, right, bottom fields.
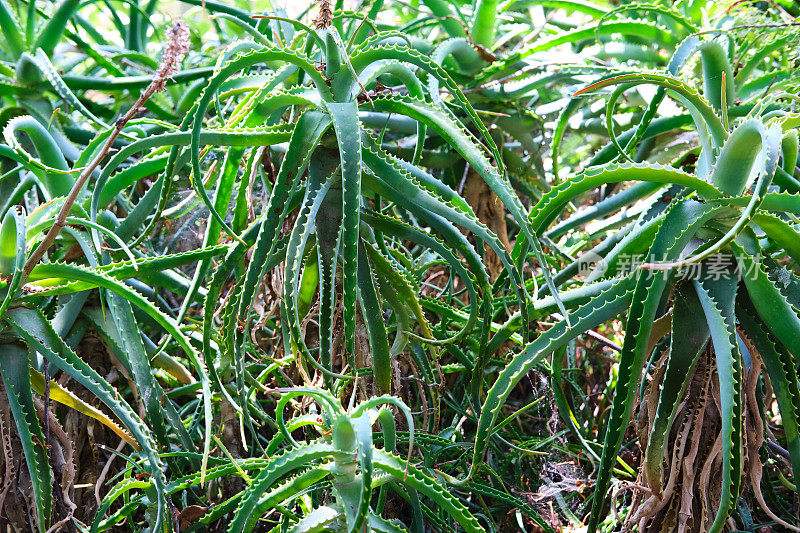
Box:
left=229, top=388, right=481, bottom=531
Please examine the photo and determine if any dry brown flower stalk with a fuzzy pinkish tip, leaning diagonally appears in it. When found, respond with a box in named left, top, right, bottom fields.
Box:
left=20, top=21, right=189, bottom=285
